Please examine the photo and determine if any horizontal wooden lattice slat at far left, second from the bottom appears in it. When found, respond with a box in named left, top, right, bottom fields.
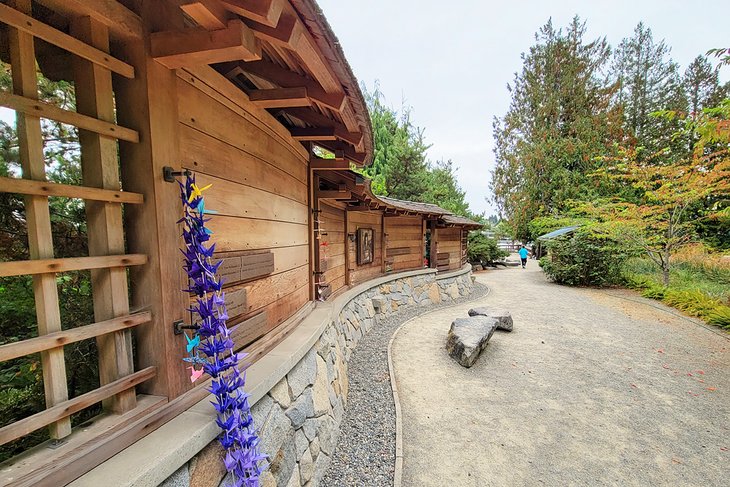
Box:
left=0, top=311, right=152, bottom=362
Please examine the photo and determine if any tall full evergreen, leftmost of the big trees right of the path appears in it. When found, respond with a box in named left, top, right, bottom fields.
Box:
left=490, top=17, right=620, bottom=238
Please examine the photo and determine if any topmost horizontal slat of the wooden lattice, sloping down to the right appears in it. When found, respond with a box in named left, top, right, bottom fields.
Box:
left=0, top=3, right=134, bottom=78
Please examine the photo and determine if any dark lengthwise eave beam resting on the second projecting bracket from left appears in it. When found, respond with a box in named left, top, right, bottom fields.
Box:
left=224, top=60, right=346, bottom=112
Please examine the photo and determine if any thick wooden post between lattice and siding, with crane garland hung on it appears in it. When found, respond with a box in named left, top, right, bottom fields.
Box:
left=114, top=2, right=192, bottom=399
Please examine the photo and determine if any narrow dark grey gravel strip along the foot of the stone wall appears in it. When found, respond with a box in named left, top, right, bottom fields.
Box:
left=321, top=283, right=489, bottom=487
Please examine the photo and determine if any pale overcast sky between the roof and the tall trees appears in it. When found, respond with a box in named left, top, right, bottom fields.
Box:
left=317, top=0, right=730, bottom=215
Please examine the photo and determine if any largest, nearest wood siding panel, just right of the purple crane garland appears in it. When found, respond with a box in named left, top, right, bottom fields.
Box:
left=177, top=68, right=309, bottom=346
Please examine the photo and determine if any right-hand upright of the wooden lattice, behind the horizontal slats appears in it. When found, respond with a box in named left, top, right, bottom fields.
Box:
left=71, top=17, right=136, bottom=413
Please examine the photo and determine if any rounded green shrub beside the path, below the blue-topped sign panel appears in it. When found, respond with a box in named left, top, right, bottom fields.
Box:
left=540, top=227, right=632, bottom=286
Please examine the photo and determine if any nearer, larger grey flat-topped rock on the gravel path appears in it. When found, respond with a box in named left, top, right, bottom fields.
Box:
left=446, top=316, right=498, bottom=367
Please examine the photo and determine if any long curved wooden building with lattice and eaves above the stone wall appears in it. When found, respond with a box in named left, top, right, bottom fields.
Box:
left=0, top=0, right=478, bottom=485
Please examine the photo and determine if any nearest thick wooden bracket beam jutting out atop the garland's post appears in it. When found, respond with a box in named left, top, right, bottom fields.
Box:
left=150, top=19, right=261, bottom=69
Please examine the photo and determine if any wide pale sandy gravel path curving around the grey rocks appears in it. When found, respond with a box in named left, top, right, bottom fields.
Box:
left=392, top=261, right=730, bottom=487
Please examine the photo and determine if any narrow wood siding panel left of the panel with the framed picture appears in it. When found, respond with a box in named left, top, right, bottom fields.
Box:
left=318, top=203, right=346, bottom=293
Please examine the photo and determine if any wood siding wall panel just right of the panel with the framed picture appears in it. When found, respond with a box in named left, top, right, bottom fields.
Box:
left=385, top=216, right=425, bottom=272
